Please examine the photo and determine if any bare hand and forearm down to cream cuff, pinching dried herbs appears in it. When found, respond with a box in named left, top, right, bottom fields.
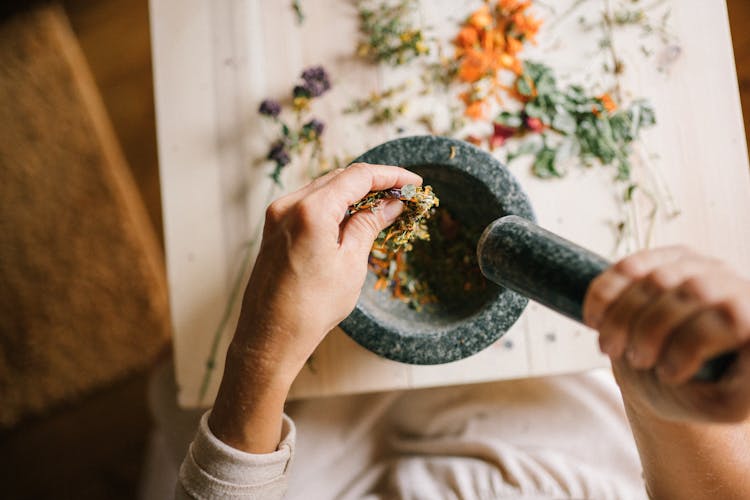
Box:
left=209, top=164, right=422, bottom=452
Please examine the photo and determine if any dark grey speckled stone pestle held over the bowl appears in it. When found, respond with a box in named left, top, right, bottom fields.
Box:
left=477, top=215, right=737, bottom=382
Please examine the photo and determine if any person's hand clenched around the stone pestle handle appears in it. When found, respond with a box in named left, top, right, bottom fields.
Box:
left=583, top=247, right=750, bottom=421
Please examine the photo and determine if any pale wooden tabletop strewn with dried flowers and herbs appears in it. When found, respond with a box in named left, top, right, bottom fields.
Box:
left=151, top=0, right=750, bottom=407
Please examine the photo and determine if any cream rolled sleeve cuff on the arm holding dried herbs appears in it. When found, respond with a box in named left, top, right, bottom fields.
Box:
left=175, top=411, right=295, bottom=500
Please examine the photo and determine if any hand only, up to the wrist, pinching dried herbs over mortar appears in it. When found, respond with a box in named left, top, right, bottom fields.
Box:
left=234, top=164, right=422, bottom=382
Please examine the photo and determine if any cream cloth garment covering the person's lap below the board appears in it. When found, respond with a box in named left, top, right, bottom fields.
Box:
left=142, top=363, right=645, bottom=500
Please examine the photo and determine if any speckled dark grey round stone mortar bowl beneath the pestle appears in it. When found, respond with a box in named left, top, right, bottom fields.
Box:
left=340, top=136, right=535, bottom=365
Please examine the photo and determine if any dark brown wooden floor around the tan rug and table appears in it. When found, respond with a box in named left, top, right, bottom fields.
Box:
left=0, top=0, right=750, bottom=500
